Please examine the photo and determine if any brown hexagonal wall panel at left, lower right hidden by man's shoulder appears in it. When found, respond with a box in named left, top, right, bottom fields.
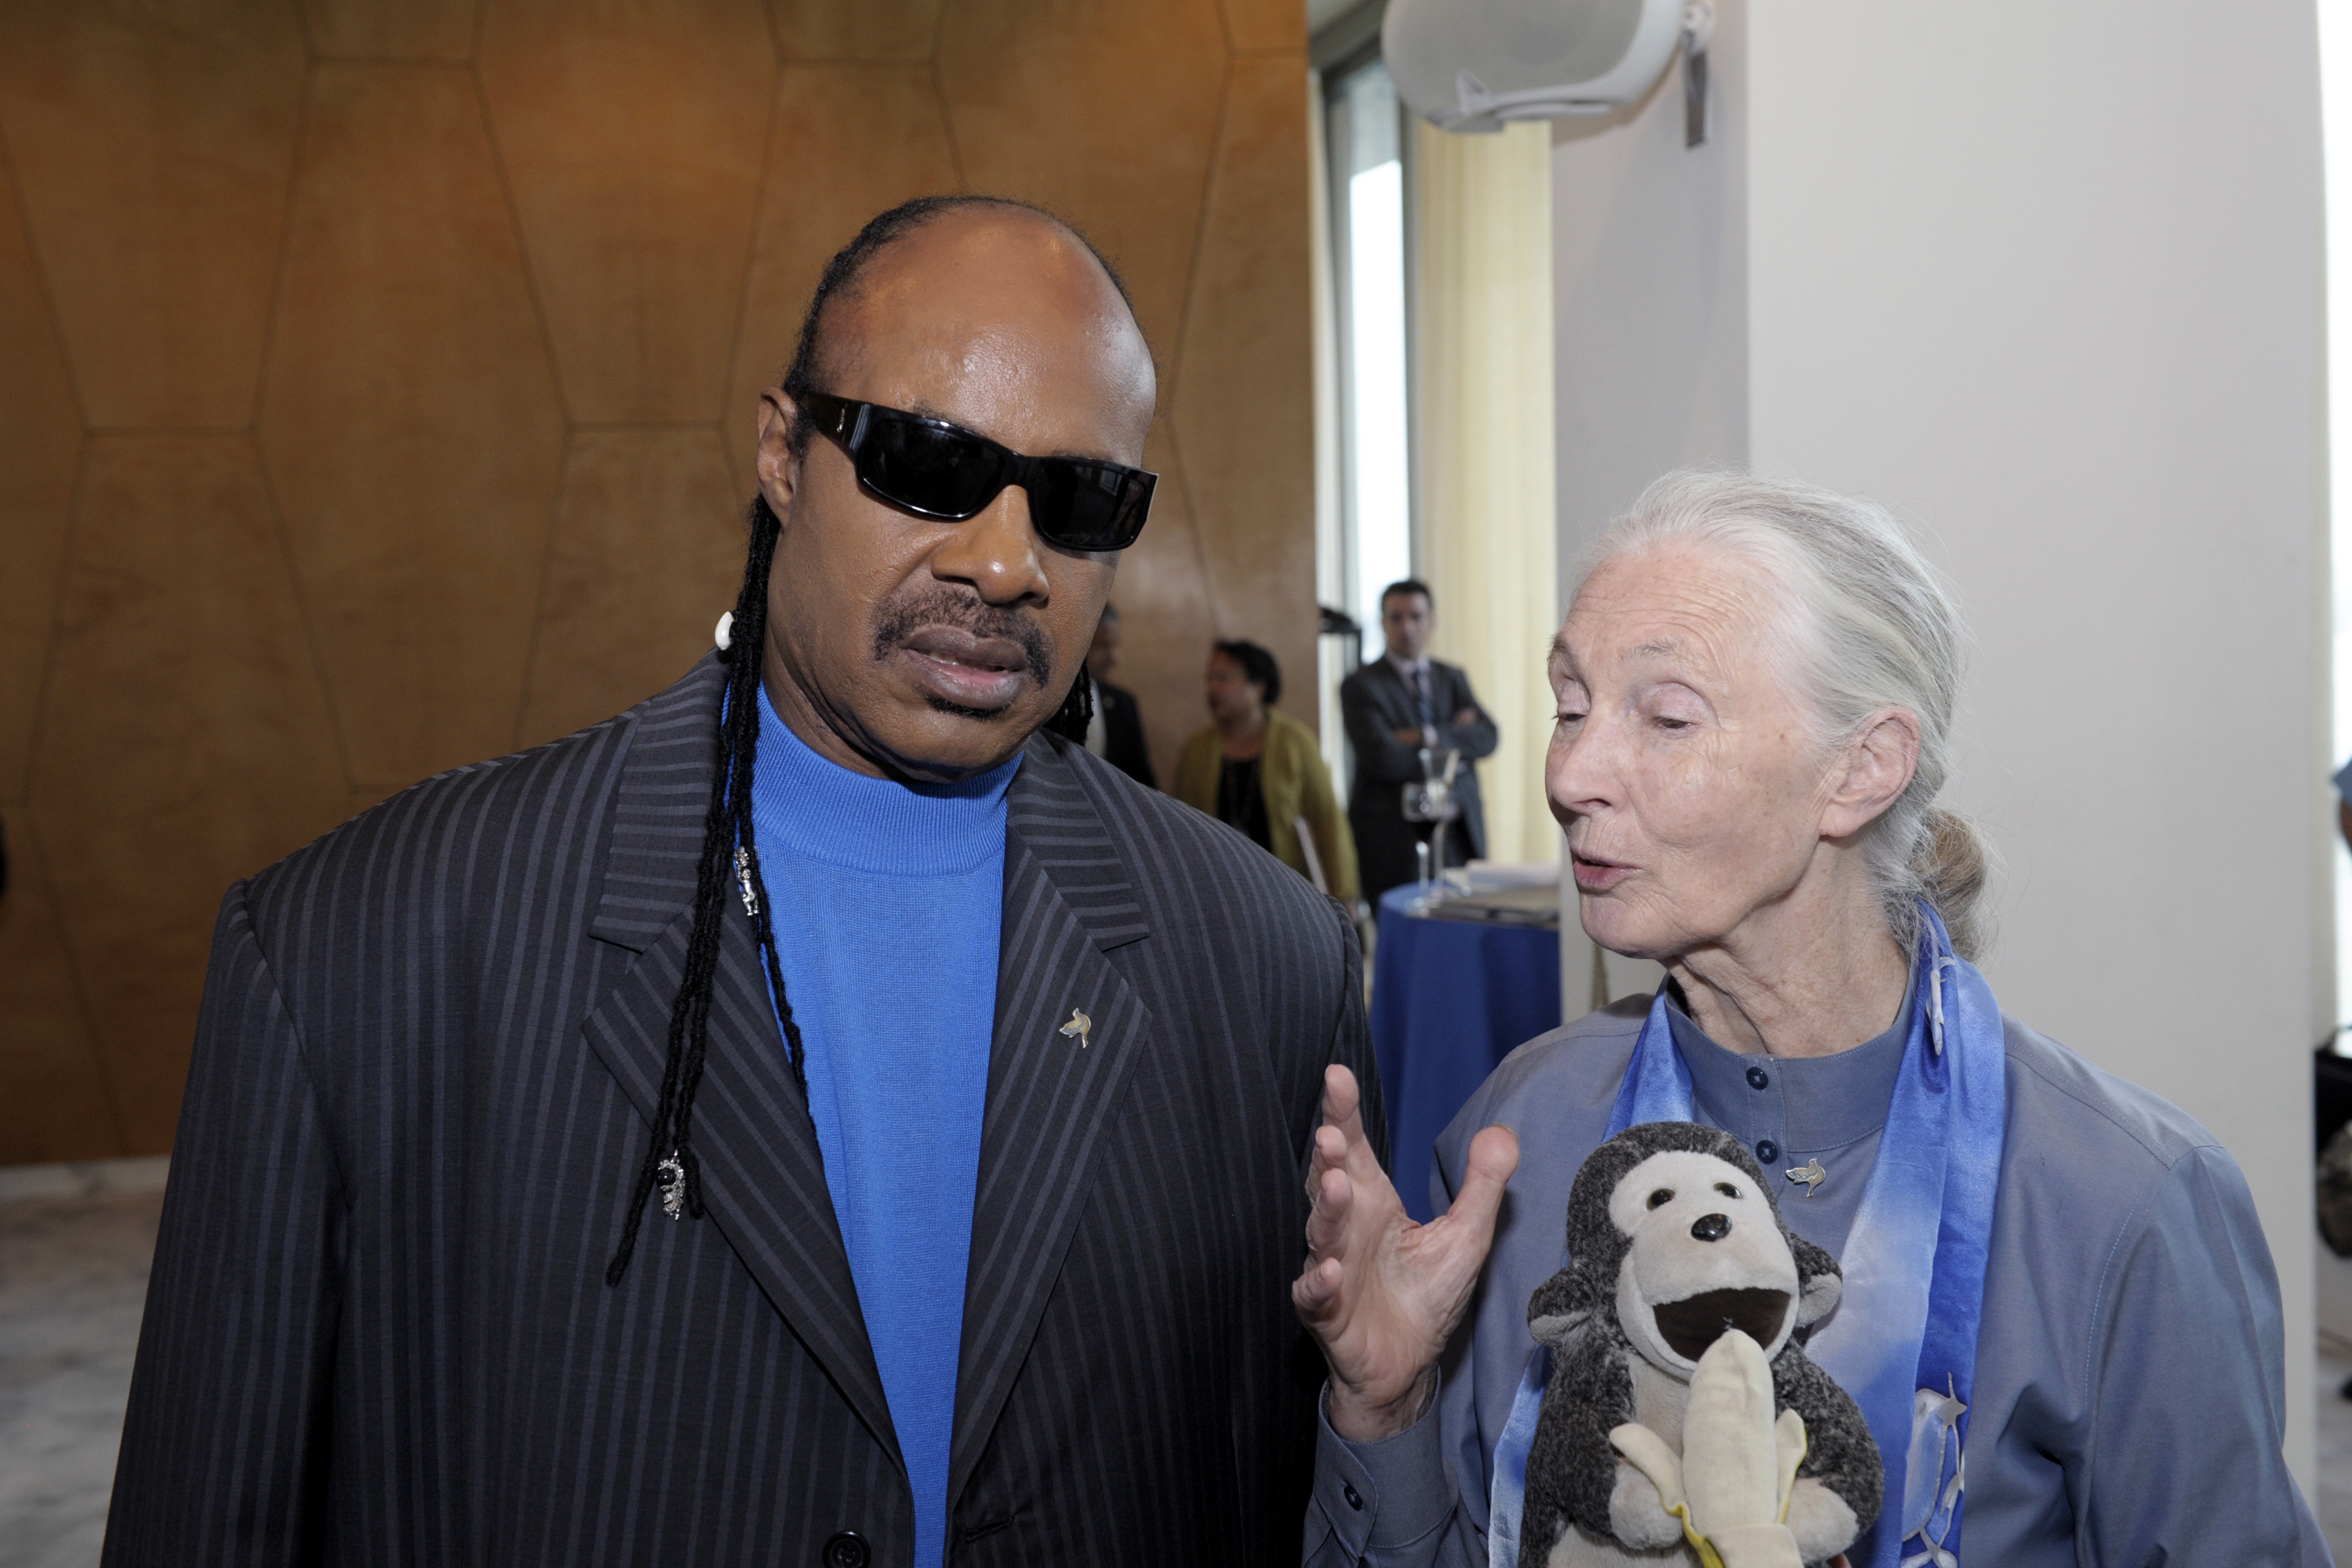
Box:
left=33, top=435, right=348, bottom=1154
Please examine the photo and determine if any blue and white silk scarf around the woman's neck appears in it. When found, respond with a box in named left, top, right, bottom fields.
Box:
left=1486, top=903, right=2008, bottom=1568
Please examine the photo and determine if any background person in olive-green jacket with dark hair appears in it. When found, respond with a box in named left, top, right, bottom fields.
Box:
left=1173, top=640, right=1357, bottom=905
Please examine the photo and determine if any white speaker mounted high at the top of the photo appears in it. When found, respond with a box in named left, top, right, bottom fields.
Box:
left=1380, top=0, right=1714, bottom=131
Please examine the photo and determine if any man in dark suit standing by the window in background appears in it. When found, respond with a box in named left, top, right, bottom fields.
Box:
left=1338, top=578, right=1501, bottom=903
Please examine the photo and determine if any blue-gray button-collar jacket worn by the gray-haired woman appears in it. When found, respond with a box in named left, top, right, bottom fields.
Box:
left=1305, top=997, right=2331, bottom=1568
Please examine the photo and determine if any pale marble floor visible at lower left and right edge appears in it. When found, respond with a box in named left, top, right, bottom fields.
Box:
left=14, top=1162, right=2352, bottom=1568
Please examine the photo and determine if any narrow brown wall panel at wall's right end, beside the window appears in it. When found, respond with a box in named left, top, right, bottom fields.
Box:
left=1171, top=54, right=1320, bottom=724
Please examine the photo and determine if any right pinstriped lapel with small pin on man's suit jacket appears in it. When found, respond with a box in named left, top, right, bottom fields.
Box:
left=948, top=740, right=1152, bottom=1509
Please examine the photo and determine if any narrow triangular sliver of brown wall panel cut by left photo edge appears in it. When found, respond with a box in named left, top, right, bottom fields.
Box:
left=0, top=150, right=82, bottom=799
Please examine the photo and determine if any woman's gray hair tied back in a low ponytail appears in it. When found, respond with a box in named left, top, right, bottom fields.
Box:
left=1578, top=470, right=1990, bottom=959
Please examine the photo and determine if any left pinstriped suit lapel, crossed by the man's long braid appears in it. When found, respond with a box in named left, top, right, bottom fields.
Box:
left=585, top=658, right=903, bottom=1465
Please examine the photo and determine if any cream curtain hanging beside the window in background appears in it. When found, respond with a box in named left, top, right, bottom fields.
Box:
left=1411, top=120, right=1560, bottom=860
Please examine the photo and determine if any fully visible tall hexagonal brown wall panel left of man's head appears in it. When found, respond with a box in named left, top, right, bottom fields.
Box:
left=261, top=66, right=564, bottom=783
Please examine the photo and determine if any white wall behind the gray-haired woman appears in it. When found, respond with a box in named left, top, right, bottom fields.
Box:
left=1555, top=0, right=2333, bottom=1488
